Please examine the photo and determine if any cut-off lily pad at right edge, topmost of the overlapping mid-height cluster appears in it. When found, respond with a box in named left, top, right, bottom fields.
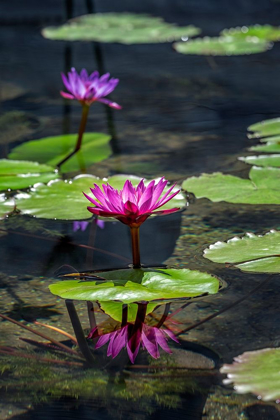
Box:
left=248, top=118, right=280, bottom=139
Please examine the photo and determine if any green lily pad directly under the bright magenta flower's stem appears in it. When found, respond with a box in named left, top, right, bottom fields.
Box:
left=50, top=269, right=219, bottom=303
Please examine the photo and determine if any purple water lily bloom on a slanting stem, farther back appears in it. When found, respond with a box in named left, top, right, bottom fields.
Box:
left=60, top=68, right=121, bottom=109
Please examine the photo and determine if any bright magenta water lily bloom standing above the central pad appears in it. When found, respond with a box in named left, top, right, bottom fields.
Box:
left=84, top=177, right=180, bottom=227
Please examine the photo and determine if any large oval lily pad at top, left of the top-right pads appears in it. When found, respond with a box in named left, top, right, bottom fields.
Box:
left=42, top=13, right=200, bottom=44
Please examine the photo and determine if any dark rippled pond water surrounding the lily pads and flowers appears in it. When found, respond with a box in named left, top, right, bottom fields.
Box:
left=0, top=0, right=280, bottom=420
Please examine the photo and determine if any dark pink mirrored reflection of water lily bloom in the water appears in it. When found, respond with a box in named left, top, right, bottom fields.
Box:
left=88, top=322, right=179, bottom=363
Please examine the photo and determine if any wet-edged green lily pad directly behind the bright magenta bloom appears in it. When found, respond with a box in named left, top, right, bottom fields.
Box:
left=16, top=174, right=186, bottom=220
